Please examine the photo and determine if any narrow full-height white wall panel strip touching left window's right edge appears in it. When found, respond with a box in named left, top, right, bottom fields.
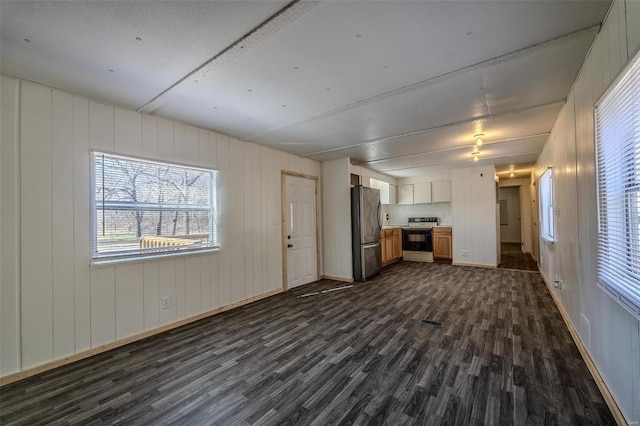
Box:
left=216, top=135, right=231, bottom=306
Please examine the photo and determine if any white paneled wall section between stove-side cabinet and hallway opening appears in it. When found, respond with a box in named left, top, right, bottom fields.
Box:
left=451, top=166, right=499, bottom=267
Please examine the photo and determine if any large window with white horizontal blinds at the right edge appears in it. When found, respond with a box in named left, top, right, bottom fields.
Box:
left=594, top=48, right=640, bottom=318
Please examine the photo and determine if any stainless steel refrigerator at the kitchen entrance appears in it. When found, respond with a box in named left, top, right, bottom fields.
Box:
left=351, top=185, right=382, bottom=281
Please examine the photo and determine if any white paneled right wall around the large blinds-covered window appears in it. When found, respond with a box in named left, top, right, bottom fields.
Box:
left=537, top=0, right=640, bottom=422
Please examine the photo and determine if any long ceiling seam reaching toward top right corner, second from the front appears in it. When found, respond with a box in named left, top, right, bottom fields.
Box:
left=242, top=24, right=600, bottom=142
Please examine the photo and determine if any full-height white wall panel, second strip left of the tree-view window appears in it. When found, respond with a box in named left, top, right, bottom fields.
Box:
left=51, top=91, right=75, bottom=359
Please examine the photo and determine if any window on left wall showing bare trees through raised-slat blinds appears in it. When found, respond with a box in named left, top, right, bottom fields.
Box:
left=92, top=152, right=219, bottom=261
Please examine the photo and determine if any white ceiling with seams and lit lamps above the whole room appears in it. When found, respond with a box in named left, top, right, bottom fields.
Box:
left=0, top=0, right=610, bottom=177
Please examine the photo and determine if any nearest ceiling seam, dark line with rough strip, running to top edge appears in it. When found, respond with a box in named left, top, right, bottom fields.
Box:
left=136, top=0, right=321, bottom=114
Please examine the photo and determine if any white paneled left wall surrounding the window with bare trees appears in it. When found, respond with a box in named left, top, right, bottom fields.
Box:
left=0, top=77, right=320, bottom=376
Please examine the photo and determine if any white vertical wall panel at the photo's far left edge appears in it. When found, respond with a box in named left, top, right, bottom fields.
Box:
left=0, top=76, right=21, bottom=376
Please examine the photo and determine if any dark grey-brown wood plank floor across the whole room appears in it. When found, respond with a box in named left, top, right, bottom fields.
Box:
left=0, top=262, right=614, bottom=425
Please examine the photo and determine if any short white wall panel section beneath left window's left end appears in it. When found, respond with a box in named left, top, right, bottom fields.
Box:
left=91, top=267, right=116, bottom=348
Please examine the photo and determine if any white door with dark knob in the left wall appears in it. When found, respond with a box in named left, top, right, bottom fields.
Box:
left=284, top=175, right=318, bottom=288
